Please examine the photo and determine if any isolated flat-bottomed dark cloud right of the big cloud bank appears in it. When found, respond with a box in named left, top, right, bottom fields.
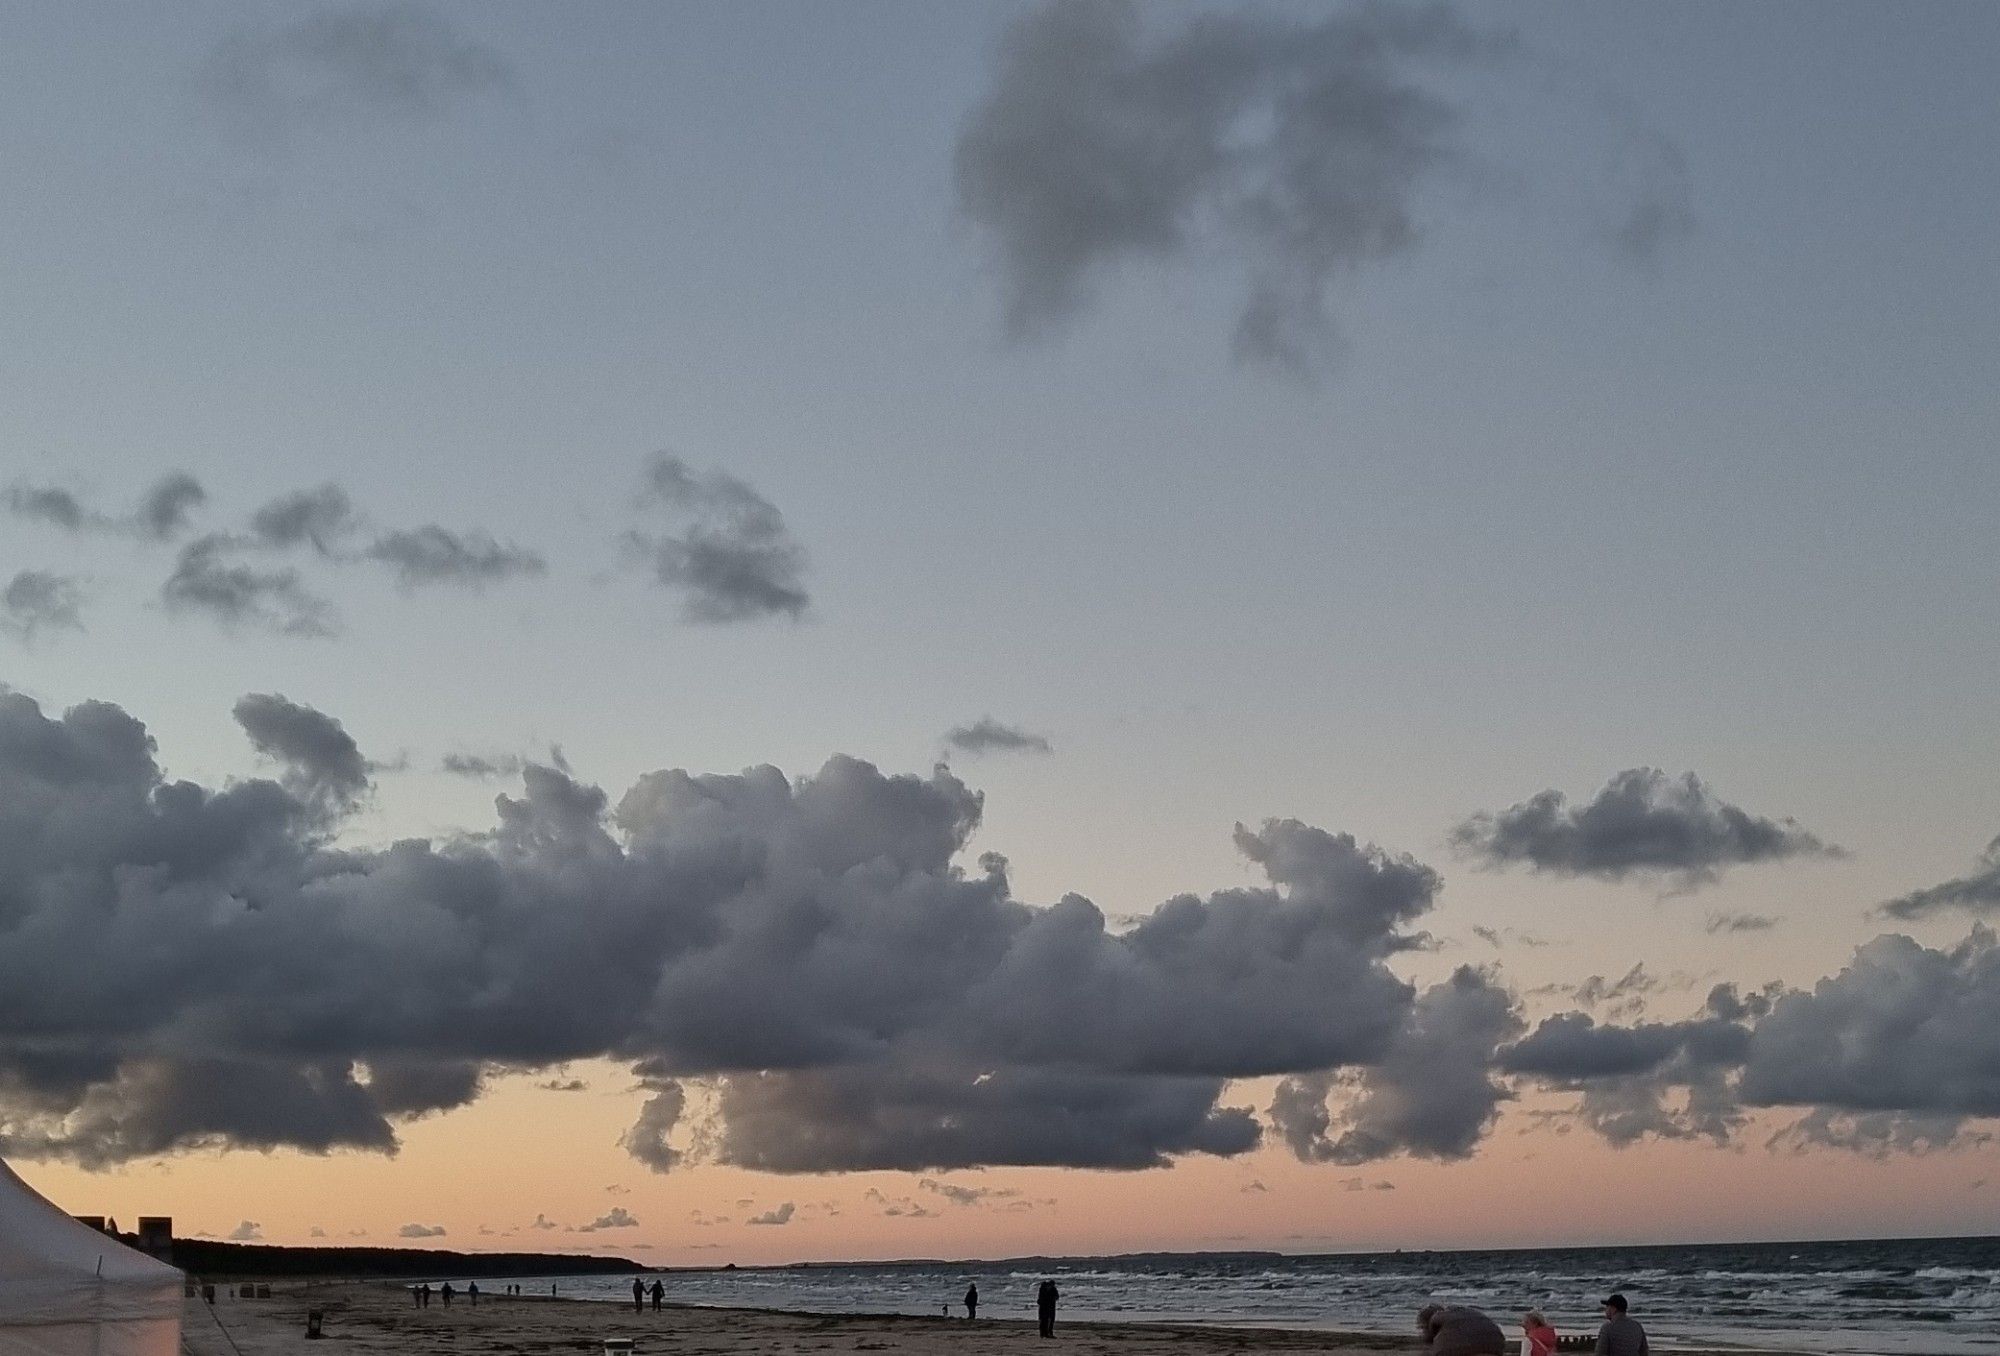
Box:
left=1452, top=768, right=1840, bottom=886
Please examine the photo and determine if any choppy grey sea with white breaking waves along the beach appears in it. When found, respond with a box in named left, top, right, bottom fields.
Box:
left=482, top=1238, right=2000, bottom=1356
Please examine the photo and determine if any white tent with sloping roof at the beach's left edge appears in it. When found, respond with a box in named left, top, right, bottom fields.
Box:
left=0, top=1162, right=182, bottom=1356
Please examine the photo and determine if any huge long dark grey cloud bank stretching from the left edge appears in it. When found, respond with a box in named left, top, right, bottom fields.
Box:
left=0, top=694, right=1456, bottom=1172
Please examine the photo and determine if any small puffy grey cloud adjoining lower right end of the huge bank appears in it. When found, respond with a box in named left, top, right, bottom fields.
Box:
left=1270, top=966, right=1520, bottom=1164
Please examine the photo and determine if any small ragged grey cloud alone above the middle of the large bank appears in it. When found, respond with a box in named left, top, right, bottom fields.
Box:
left=626, top=454, right=812, bottom=622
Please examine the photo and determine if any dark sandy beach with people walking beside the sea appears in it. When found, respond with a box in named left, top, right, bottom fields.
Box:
left=182, top=1282, right=1416, bottom=1356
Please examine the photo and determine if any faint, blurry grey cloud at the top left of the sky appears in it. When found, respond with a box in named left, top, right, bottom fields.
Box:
left=202, top=4, right=514, bottom=134
